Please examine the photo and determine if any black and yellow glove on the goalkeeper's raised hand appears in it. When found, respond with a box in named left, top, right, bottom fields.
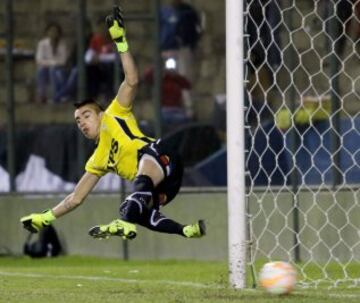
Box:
left=105, top=6, right=129, bottom=53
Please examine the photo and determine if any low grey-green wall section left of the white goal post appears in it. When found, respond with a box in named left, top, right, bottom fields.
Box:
left=0, top=194, right=227, bottom=259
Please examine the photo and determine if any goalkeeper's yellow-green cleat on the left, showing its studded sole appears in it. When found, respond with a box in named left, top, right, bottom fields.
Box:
left=89, top=219, right=136, bottom=239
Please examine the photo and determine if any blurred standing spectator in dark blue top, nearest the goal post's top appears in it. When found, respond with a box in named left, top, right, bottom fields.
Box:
left=160, top=0, right=201, bottom=82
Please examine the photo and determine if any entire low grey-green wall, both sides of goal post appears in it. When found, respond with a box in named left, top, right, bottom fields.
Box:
left=0, top=190, right=360, bottom=262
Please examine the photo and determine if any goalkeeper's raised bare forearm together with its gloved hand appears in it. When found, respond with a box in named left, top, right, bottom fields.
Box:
left=106, top=6, right=139, bottom=107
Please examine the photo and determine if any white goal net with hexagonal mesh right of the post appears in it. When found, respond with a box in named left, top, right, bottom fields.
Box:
left=244, top=0, right=360, bottom=287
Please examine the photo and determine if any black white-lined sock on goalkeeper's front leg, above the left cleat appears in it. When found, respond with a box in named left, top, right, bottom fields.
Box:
left=120, top=175, right=154, bottom=223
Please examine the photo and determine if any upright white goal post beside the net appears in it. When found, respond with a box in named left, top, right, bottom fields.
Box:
left=226, top=0, right=246, bottom=288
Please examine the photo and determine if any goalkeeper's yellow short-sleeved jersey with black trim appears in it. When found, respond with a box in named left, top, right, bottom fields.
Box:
left=85, top=98, right=154, bottom=180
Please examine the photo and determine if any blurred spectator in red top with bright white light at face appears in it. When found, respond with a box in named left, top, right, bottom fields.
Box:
left=143, top=60, right=193, bottom=124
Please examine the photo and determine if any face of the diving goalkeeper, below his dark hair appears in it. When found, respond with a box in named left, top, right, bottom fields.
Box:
left=74, top=104, right=102, bottom=140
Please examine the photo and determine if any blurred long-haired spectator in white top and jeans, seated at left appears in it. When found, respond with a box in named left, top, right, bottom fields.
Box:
left=35, top=23, right=68, bottom=103
